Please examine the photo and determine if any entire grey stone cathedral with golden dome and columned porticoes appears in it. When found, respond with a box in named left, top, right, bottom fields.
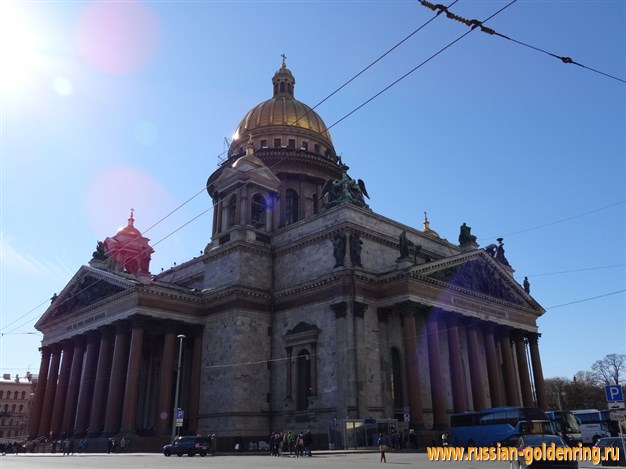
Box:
left=28, top=59, right=546, bottom=450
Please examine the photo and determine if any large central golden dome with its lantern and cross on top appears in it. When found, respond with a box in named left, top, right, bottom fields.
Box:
left=228, top=62, right=335, bottom=159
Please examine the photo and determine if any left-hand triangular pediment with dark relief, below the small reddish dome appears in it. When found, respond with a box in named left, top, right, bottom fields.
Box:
left=35, top=266, right=136, bottom=328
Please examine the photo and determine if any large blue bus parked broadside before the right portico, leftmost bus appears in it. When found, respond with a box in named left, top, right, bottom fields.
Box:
left=450, top=407, right=553, bottom=447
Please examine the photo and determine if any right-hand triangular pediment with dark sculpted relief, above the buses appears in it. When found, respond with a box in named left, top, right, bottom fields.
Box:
left=413, top=249, right=542, bottom=309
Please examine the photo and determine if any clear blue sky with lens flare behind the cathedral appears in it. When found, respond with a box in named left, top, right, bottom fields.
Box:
left=0, top=0, right=626, bottom=384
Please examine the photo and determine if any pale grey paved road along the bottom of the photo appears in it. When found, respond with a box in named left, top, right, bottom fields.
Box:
left=0, top=452, right=598, bottom=469
